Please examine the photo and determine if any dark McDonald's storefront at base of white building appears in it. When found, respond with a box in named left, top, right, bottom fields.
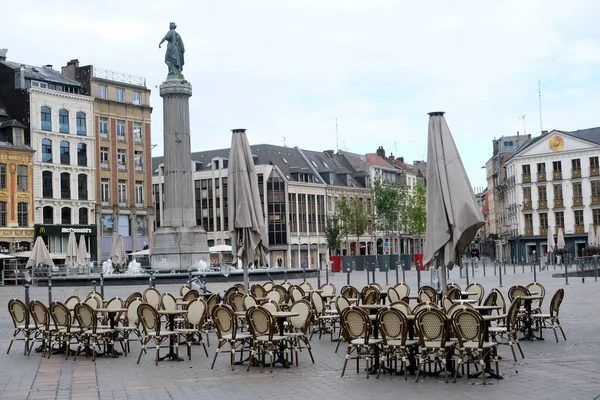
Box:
left=34, top=224, right=98, bottom=260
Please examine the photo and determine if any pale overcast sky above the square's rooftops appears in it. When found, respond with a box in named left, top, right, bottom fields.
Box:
left=0, top=0, right=600, bottom=186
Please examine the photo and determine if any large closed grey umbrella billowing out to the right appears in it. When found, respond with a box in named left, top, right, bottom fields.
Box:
left=423, top=112, right=484, bottom=294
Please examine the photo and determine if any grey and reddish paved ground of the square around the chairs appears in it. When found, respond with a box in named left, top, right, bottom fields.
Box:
left=0, top=264, right=600, bottom=400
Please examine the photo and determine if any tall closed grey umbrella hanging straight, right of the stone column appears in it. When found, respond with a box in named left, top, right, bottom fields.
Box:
left=227, top=129, right=269, bottom=290
